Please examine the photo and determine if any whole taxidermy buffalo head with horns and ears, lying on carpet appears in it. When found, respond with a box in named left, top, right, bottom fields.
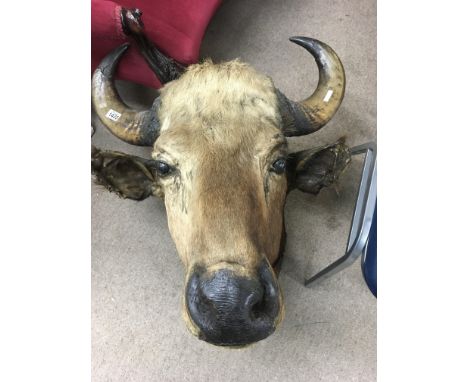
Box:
left=92, top=37, right=350, bottom=346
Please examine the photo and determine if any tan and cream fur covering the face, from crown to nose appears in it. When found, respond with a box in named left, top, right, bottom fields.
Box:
left=152, top=61, right=287, bottom=330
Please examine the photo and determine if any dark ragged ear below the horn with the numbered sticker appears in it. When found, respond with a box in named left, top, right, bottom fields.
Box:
left=91, top=146, right=159, bottom=200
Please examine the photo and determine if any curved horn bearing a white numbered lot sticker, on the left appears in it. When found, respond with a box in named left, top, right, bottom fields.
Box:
left=91, top=44, right=159, bottom=146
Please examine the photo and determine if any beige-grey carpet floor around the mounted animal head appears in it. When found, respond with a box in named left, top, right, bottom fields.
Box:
left=92, top=0, right=376, bottom=382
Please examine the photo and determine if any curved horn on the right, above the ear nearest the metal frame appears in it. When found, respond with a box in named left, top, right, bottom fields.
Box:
left=276, top=37, right=346, bottom=136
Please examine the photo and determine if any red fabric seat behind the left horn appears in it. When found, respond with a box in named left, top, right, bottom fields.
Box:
left=91, top=0, right=221, bottom=88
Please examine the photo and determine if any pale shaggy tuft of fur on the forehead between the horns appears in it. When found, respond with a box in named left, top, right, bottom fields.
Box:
left=159, top=61, right=281, bottom=146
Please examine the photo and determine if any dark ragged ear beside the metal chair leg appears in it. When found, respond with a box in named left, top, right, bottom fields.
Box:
left=287, top=138, right=351, bottom=195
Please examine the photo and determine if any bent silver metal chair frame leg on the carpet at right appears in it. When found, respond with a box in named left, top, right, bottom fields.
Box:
left=305, top=142, right=377, bottom=287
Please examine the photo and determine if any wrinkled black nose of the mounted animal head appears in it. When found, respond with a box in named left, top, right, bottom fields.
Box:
left=186, top=264, right=280, bottom=346
